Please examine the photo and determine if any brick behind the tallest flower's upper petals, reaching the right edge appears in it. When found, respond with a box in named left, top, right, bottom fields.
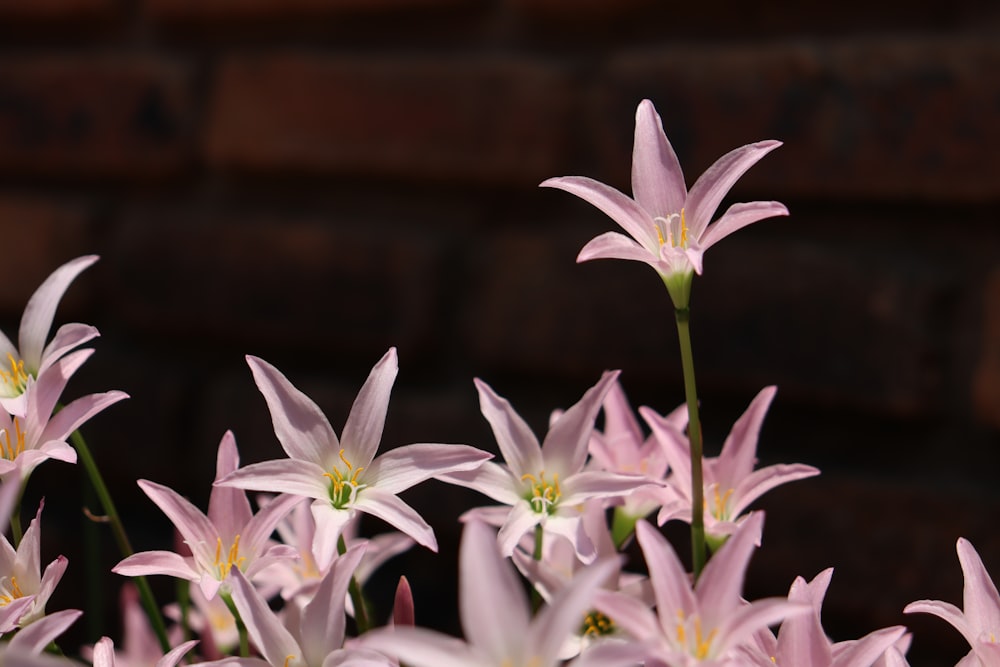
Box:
left=590, top=38, right=1000, bottom=200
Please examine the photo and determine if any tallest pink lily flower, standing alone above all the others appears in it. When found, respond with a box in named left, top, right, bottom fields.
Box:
left=541, top=100, right=788, bottom=309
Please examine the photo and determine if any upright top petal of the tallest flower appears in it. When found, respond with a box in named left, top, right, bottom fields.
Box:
left=632, top=100, right=687, bottom=217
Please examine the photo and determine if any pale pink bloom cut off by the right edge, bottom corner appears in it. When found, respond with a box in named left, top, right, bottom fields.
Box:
left=903, top=537, right=1000, bottom=667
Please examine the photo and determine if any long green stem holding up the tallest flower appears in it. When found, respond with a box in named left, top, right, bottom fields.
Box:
left=674, top=308, right=706, bottom=581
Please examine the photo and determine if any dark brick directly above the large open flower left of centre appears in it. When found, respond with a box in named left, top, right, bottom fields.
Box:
left=107, top=211, right=437, bottom=363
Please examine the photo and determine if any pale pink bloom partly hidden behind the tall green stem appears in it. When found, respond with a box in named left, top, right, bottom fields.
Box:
left=639, top=387, right=819, bottom=539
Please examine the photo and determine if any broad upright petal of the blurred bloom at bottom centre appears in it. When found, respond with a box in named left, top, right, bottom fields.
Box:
left=459, top=521, right=531, bottom=665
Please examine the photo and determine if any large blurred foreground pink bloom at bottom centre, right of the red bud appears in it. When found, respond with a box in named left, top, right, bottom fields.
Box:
left=359, top=520, right=632, bottom=667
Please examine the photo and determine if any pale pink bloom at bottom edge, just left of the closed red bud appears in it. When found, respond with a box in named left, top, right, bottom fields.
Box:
left=191, top=546, right=393, bottom=667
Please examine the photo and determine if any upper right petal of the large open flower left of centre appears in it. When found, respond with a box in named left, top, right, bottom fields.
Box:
left=341, top=347, right=399, bottom=467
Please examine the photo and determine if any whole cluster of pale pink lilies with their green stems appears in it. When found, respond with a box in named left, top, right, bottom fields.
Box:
left=0, top=101, right=1000, bottom=667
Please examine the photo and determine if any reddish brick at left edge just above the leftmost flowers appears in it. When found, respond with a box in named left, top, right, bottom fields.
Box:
left=0, top=196, right=95, bottom=314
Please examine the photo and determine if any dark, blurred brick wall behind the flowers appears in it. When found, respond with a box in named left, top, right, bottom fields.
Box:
left=0, top=0, right=1000, bottom=665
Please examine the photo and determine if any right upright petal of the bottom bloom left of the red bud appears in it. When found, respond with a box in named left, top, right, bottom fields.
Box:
left=299, top=544, right=365, bottom=665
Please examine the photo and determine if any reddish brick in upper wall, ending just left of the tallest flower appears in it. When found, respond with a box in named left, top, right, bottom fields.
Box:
left=207, top=54, right=570, bottom=187
